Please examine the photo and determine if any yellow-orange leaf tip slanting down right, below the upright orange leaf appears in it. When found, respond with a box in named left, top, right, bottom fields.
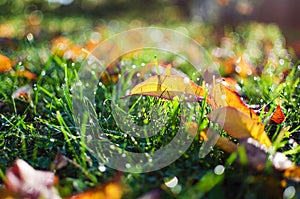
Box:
left=208, top=106, right=272, bottom=147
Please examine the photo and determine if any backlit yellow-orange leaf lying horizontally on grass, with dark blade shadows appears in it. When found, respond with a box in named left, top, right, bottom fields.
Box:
left=130, top=75, right=205, bottom=101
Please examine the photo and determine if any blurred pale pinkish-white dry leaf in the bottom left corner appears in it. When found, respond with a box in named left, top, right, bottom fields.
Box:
left=5, top=159, right=61, bottom=199
